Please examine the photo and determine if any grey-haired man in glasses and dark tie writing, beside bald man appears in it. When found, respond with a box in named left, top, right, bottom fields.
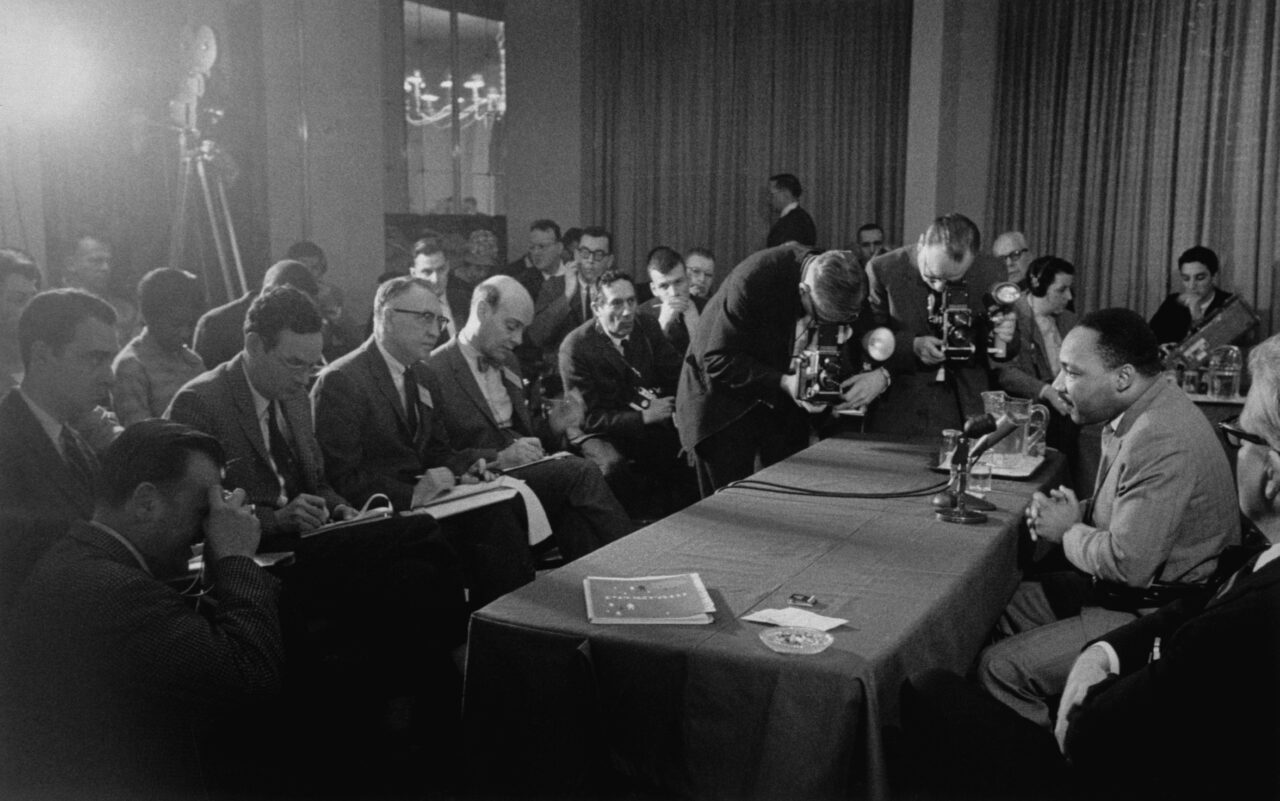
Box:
left=311, top=276, right=534, bottom=601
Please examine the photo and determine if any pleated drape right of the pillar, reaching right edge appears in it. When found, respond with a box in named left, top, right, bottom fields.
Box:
left=987, top=0, right=1280, bottom=333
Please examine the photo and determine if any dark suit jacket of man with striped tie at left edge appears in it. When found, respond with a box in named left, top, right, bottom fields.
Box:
left=0, top=389, right=97, bottom=527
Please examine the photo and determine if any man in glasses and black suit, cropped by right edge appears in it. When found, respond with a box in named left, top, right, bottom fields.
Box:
left=904, top=337, right=1280, bottom=800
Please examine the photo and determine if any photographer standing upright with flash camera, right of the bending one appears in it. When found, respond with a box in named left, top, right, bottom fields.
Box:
left=867, top=214, right=1019, bottom=436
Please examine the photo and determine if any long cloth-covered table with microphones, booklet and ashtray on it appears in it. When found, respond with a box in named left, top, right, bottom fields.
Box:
left=463, top=436, right=1065, bottom=798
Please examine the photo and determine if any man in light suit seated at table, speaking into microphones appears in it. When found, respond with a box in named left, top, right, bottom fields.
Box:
left=978, top=308, right=1240, bottom=728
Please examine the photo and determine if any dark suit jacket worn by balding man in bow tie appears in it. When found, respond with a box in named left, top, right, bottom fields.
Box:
left=426, top=340, right=542, bottom=462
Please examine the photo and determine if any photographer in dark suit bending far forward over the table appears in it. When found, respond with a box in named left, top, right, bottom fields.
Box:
left=676, top=244, right=888, bottom=496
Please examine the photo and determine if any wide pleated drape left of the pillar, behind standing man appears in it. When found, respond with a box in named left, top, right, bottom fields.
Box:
left=581, top=0, right=911, bottom=275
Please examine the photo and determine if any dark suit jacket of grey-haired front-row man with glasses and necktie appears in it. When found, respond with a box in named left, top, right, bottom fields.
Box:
left=311, top=338, right=481, bottom=509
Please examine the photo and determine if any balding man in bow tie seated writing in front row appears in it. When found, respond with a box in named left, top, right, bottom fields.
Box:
left=426, top=275, right=631, bottom=559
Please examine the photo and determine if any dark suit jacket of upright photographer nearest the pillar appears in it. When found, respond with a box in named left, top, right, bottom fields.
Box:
left=867, top=244, right=1019, bottom=436
